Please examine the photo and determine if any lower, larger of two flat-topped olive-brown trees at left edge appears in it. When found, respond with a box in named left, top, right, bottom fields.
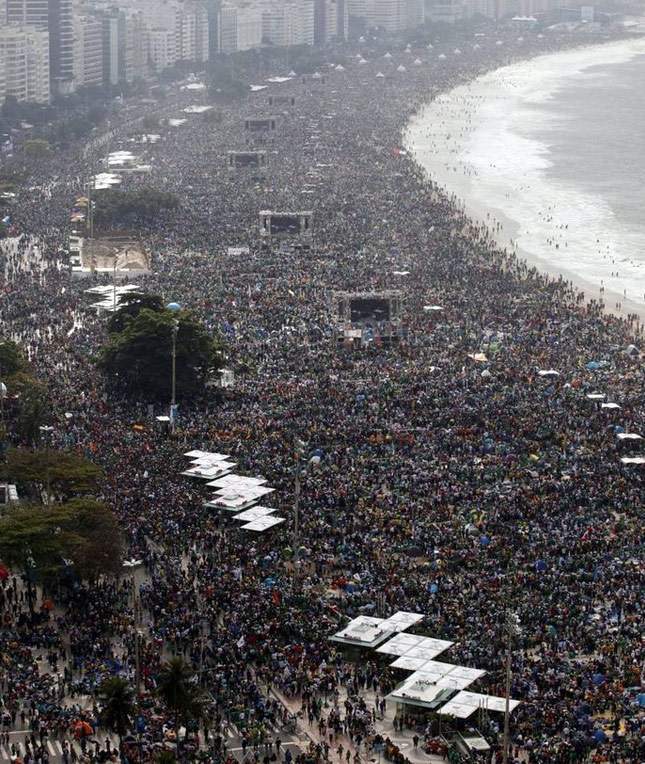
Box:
left=0, top=499, right=123, bottom=579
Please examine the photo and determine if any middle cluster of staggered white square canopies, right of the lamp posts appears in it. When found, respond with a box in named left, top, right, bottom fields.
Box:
left=181, top=449, right=285, bottom=533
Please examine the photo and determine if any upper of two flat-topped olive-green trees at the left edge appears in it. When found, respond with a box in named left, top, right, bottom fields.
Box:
left=0, top=448, right=102, bottom=500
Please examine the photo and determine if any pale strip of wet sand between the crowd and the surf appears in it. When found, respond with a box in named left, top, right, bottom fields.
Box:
left=401, top=40, right=645, bottom=325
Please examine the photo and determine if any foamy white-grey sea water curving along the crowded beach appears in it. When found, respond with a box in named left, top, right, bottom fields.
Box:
left=405, top=37, right=645, bottom=315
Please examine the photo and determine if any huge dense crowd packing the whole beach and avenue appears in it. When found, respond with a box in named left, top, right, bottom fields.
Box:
left=0, top=19, right=645, bottom=764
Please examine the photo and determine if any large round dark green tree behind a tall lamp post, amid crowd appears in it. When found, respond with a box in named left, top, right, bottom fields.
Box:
left=98, top=308, right=221, bottom=400
